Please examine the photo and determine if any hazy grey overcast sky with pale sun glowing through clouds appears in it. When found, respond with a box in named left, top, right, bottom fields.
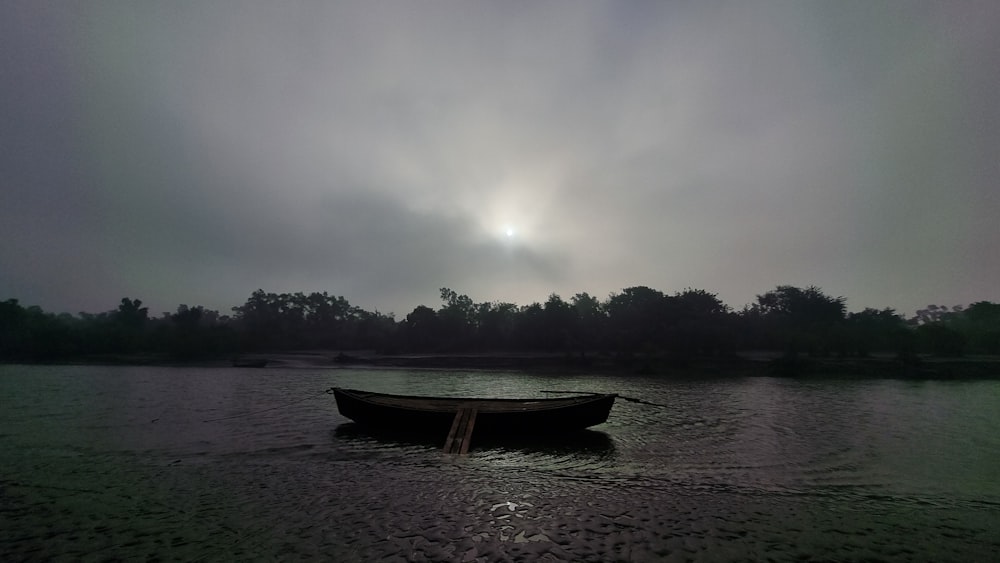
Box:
left=0, top=0, right=1000, bottom=318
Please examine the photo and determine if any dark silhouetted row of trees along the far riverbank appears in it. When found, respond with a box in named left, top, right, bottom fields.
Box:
left=0, top=285, right=1000, bottom=361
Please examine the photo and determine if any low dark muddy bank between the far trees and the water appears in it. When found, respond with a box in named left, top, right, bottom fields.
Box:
left=7, top=350, right=1000, bottom=379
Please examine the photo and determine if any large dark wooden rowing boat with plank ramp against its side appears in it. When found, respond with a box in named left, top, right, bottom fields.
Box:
left=333, top=388, right=618, bottom=453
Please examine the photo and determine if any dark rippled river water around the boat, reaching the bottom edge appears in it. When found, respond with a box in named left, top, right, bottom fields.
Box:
left=0, top=366, right=1000, bottom=561
